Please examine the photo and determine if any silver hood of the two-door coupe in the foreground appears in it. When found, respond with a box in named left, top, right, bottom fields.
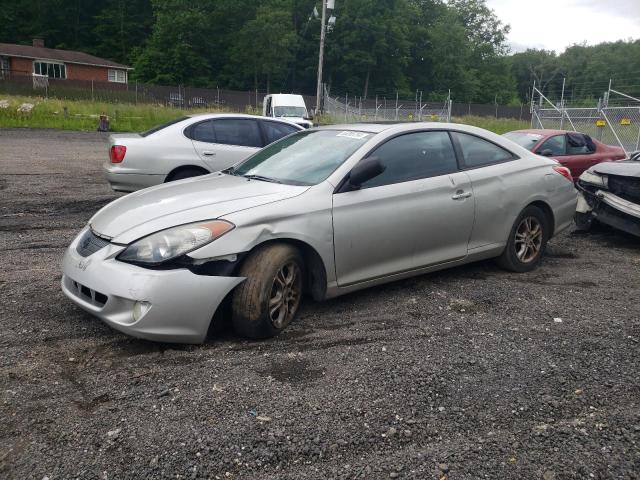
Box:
left=89, top=173, right=309, bottom=244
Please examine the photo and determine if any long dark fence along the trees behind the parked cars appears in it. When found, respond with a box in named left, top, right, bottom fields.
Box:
left=0, top=71, right=530, bottom=122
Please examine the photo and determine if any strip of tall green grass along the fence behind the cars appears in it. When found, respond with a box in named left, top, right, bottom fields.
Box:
left=0, top=94, right=529, bottom=134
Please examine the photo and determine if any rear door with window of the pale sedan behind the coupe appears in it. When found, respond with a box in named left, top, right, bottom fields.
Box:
left=187, top=118, right=264, bottom=171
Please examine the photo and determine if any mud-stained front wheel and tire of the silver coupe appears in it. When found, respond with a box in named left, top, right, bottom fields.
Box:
left=231, top=244, right=304, bottom=340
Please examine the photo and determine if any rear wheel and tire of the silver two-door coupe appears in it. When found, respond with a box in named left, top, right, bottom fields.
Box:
left=496, top=205, right=551, bottom=273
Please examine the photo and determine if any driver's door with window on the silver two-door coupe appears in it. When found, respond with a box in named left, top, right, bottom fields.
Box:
left=333, top=131, right=474, bottom=286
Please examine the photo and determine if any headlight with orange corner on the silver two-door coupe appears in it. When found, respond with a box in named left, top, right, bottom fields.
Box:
left=117, top=220, right=235, bottom=265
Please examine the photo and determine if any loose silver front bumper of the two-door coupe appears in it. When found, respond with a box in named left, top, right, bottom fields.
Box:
left=61, top=231, right=243, bottom=343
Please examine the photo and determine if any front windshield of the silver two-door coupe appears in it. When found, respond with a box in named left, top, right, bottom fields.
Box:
left=227, top=130, right=373, bottom=185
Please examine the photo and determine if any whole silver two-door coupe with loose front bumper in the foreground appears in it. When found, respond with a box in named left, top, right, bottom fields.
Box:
left=62, top=123, right=576, bottom=343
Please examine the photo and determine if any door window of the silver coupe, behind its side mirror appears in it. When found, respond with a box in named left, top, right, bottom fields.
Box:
left=362, top=132, right=458, bottom=188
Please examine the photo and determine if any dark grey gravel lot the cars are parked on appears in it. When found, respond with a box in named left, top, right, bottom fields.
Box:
left=0, top=130, right=640, bottom=480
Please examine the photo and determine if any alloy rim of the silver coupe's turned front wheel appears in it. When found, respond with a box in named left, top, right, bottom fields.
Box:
left=269, top=262, right=302, bottom=328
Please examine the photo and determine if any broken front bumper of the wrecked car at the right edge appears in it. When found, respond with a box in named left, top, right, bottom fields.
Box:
left=576, top=183, right=640, bottom=237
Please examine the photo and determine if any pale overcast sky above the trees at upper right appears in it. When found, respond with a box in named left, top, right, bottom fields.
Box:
left=487, top=0, right=640, bottom=53
